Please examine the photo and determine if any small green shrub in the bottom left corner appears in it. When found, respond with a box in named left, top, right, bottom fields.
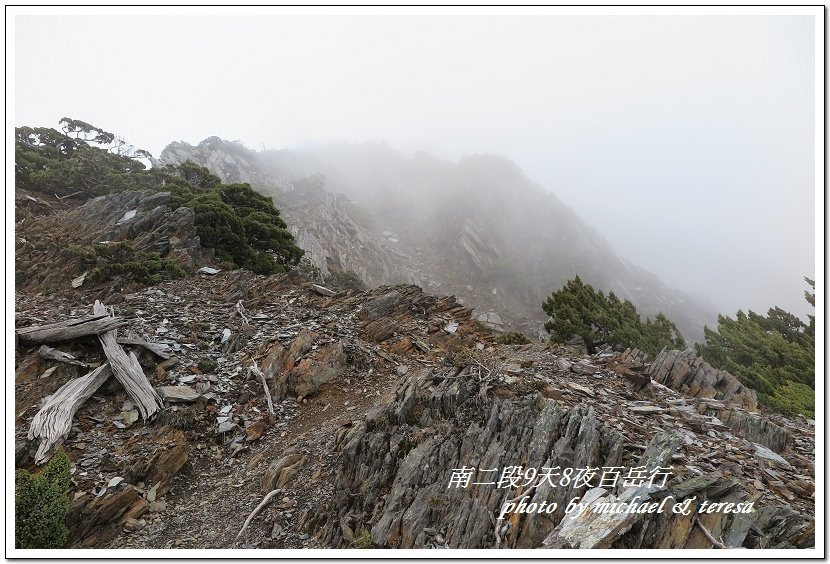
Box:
left=14, top=451, right=72, bottom=548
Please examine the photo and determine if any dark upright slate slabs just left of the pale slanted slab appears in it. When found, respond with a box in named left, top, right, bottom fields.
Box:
left=316, top=369, right=622, bottom=548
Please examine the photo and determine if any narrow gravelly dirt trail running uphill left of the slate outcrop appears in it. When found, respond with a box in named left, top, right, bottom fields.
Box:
left=107, top=373, right=404, bottom=548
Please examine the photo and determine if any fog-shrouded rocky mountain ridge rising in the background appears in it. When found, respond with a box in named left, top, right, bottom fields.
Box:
left=161, top=137, right=715, bottom=340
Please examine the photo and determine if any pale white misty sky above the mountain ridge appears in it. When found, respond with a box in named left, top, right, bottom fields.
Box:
left=14, top=9, right=821, bottom=314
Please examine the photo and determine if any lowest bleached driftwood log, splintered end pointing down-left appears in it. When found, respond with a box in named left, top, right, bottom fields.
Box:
left=29, top=364, right=112, bottom=464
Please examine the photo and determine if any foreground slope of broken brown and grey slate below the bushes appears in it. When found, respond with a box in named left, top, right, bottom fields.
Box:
left=15, top=271, right=815, bottom=548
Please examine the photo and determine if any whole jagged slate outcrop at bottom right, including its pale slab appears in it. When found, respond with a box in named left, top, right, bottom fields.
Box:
left=305, top=367, right=814, bottom=548
